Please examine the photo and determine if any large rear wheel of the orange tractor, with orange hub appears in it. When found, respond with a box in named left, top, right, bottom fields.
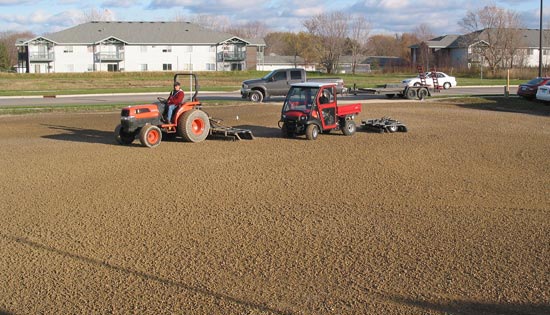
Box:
left=177, top=109, right=210, bottom=142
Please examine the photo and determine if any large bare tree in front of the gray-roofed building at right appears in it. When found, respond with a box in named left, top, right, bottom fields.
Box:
left=459, top=5, right=523, bottom=73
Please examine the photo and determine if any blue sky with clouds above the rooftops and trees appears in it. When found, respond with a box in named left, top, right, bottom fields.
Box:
left=0, top=0, right=550, bottom=34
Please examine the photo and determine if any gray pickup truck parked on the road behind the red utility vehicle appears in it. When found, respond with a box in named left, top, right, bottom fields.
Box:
left=241, top=68, right=346, bottom=102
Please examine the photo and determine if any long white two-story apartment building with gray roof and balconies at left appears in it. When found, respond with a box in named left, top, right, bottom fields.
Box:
left=16, top=21, right=265, bottom=73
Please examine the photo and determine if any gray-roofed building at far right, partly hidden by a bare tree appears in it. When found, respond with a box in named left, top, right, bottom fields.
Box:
left=409, top=29, right=550, bottom=69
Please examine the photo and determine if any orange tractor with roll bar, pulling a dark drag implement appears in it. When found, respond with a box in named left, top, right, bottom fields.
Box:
left=115, top=73, right=254, bottom=148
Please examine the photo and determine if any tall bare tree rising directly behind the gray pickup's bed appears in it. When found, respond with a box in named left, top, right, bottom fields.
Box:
left=304, top=11, right=349, bottom=73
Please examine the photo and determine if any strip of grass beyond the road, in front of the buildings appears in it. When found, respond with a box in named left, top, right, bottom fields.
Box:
left=0, top=71, right=524, bottom=96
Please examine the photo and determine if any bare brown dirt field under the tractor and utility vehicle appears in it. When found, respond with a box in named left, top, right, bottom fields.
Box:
left=0, top=102, right=550, bottom=315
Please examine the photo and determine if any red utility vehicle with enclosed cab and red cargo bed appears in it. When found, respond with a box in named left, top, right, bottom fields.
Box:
left=279, top=82, right=361, bottom=140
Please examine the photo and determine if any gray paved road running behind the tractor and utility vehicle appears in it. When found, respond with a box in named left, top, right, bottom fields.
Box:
left=0, top=87, right=517, bottom=107
